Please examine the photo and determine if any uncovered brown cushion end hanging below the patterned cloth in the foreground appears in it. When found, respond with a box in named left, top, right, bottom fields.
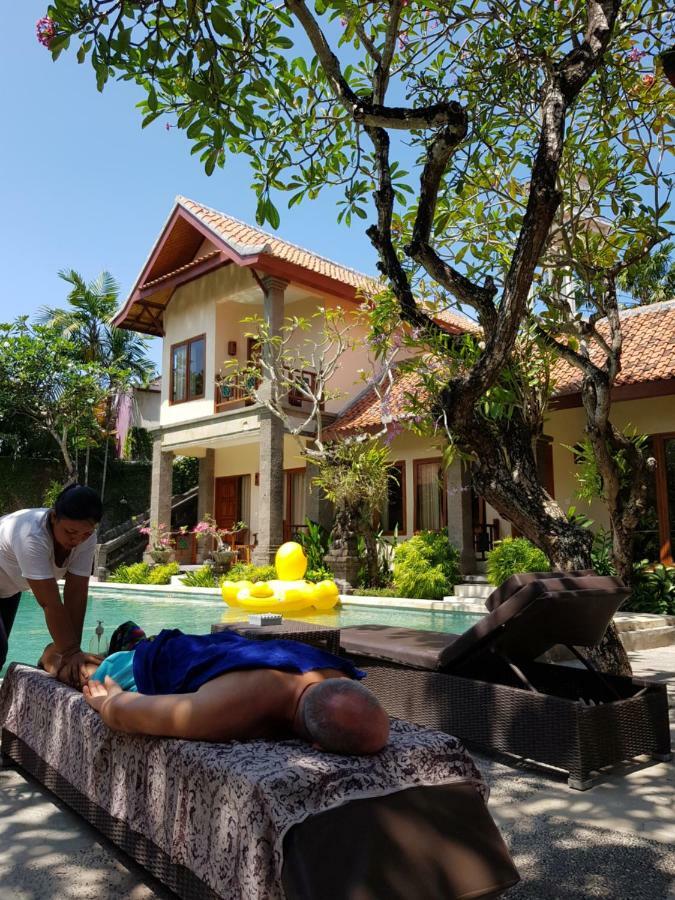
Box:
left=282, top=784, right=518, bottom=900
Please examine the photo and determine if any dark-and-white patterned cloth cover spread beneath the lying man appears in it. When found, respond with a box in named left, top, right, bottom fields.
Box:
left=0, top=663, right=487, bottom=900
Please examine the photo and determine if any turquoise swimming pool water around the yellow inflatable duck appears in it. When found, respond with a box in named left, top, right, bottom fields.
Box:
left=0, top=587, right=480, bottom=676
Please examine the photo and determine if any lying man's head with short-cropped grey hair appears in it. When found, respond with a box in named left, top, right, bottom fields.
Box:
left=298, top=678, right=389, bottom=754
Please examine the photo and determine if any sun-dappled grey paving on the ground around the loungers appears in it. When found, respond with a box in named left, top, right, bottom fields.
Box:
left=0, top=647, right=675, bottom=900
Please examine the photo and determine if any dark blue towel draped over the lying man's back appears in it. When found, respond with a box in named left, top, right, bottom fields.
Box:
left=134, top=629, right=365, bottom=694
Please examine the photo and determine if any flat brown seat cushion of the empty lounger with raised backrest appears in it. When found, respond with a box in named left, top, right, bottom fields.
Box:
left=340, top=625, right=459, bottom=670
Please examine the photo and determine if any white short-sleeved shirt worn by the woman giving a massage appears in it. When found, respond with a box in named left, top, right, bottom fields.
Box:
left=0, top=509, right=96, bottom=598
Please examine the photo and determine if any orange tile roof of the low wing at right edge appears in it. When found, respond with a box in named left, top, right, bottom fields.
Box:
left=553, top=300, right=675, bottom=397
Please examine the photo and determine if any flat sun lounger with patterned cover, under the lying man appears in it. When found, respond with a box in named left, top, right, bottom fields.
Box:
left=0, top=664, right=518, bottom=900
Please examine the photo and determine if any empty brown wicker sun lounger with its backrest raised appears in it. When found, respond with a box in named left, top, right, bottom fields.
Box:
left=340, top=573, right=671, bottom=790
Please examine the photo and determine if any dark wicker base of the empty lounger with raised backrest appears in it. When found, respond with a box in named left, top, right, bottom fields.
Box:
left=350, top=654, right=671, bottom=790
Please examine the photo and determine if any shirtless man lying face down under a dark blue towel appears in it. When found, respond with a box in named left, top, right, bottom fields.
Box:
left=41, top=623, right=389, bottom=755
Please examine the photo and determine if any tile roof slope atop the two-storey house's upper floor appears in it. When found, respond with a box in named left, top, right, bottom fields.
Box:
left=176, top=196, right=381, bottom=294
